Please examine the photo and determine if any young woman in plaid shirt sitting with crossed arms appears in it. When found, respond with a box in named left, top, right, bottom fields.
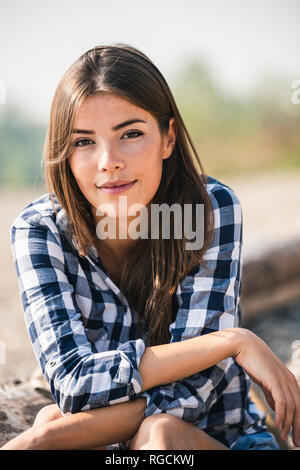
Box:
left=3, top=44, right=300, bottom=450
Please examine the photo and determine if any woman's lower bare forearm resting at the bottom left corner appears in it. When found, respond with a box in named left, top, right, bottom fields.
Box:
left=1, top=398, right=146, bottom=450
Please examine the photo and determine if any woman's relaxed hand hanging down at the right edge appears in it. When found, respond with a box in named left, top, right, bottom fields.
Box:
left=235, top=328, right=300, bottom=447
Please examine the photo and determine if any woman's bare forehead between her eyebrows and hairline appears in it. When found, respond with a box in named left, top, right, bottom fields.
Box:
left=75, top=93, right=155, bottom=127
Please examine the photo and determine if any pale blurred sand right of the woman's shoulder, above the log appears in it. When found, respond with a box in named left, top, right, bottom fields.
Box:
left=222, top=171, right=300, bottom=260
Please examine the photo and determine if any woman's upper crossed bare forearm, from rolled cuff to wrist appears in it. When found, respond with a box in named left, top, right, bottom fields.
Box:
left=138, top=328, right=248, bottom=392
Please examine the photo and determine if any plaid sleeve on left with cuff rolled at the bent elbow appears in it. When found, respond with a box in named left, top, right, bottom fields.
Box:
left=11, top=218, right=145, bottom=414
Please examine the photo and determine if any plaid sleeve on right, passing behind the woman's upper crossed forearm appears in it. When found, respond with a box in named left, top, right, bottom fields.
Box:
left=140, top=185, right=242, bottom=421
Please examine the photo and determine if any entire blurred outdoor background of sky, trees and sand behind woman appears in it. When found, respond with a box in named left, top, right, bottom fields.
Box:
left=0, top=0, right=300, bottom=424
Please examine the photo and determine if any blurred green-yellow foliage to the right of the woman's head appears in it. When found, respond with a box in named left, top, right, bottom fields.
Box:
left=173, top=58, right=300, bottom=176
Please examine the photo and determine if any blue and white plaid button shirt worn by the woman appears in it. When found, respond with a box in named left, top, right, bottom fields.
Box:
left=11, top=177, right=267, bottom=449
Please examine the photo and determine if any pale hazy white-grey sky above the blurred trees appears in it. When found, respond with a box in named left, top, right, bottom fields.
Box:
left=0, top=0, right=300, bottom=124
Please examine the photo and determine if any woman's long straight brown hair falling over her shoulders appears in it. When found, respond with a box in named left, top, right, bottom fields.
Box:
left=43, top=43, right=214, bottom=346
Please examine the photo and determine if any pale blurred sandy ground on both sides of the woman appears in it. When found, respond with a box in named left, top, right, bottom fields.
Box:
left=0, top=171, right=300, bottom=383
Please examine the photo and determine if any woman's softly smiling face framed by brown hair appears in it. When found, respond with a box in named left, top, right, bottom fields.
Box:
left=69, top=93, right=176, bottom=222
